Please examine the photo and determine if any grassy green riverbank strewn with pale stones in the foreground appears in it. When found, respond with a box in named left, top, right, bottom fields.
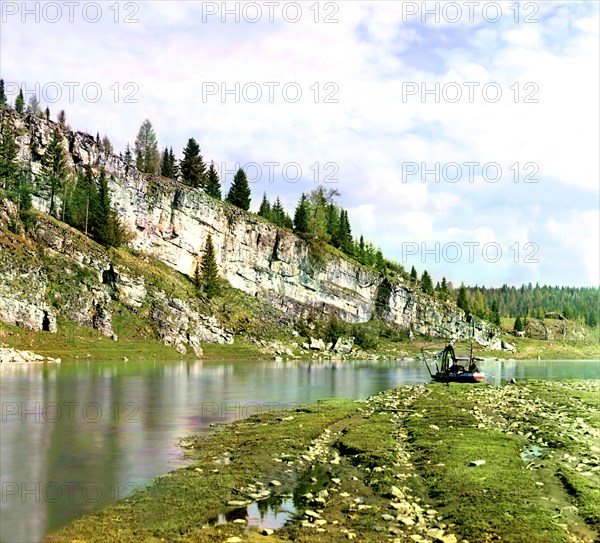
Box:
left=45, top=380, right=600, bottom=543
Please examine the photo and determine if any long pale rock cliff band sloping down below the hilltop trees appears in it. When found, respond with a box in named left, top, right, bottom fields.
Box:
left=0, top=110, right=497, bottom=344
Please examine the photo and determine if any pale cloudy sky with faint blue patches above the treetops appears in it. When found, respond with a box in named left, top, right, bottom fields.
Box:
left=0, top=0, right=600, bottom=286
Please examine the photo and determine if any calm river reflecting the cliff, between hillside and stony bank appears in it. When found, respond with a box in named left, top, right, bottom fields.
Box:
left=0, top=361, right=600, bottom=543
